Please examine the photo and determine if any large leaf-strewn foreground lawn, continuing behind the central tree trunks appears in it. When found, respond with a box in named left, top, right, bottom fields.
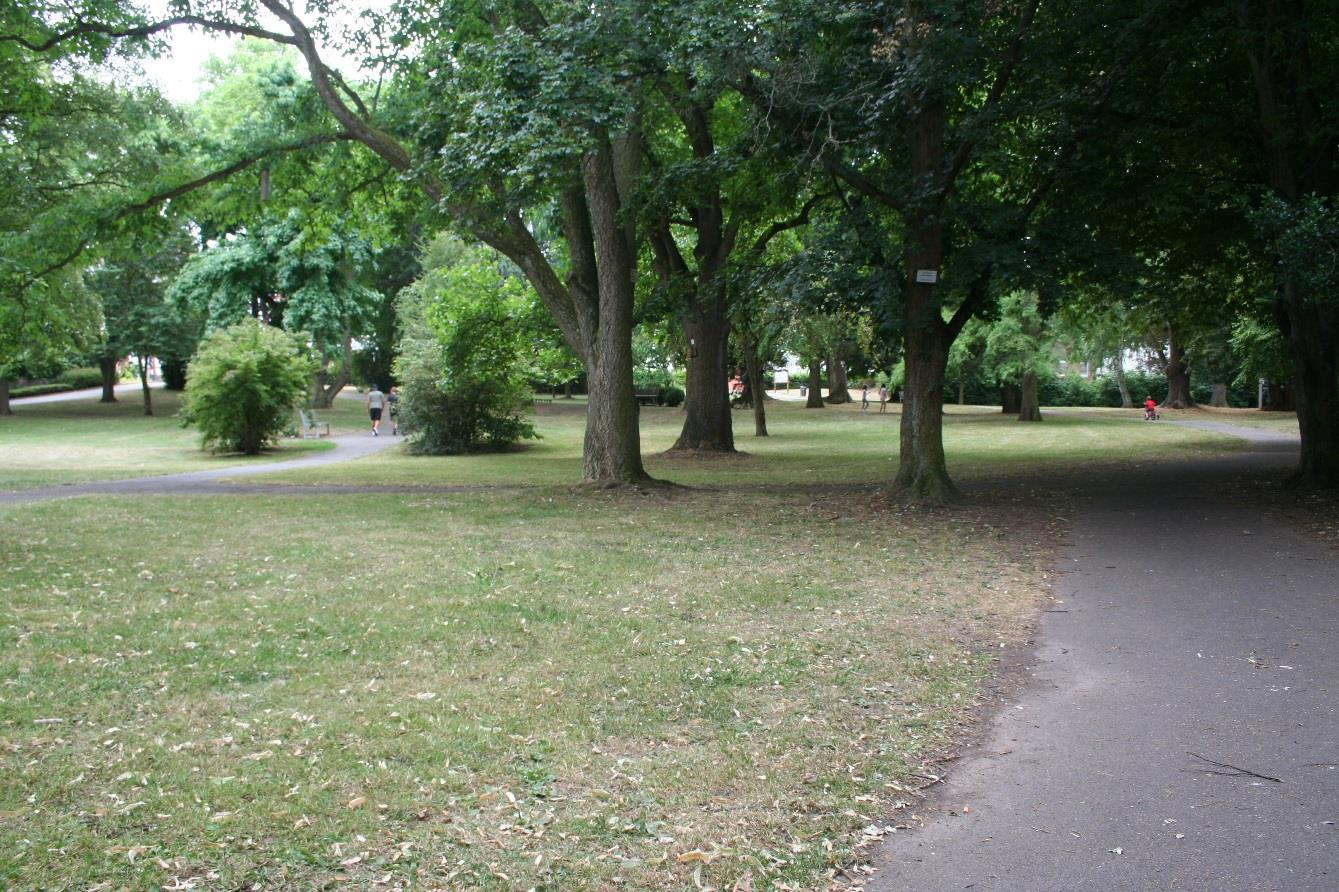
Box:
left=0, top=400, right=1253, bottom=891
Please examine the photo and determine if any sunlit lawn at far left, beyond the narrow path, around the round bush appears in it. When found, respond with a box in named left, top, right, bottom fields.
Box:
left=0, top=390, right=334, bottom=490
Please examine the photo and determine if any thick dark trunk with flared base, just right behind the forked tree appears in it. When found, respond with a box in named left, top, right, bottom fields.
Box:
left=670, top=300, right=735, bottom=453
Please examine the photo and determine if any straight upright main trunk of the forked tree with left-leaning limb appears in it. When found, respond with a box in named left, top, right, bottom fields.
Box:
left=581, top=146, right=648, bottom=485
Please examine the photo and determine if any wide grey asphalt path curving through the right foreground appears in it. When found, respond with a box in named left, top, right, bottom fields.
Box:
left=865, top=422, right=1339, bottom=892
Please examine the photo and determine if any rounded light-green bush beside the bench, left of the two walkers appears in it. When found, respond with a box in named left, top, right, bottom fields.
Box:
left=181, top=319, right=315, bottom=455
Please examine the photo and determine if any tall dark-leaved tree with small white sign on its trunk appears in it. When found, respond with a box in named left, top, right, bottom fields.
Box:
left=750, top=0, right=1157, bottom=502
